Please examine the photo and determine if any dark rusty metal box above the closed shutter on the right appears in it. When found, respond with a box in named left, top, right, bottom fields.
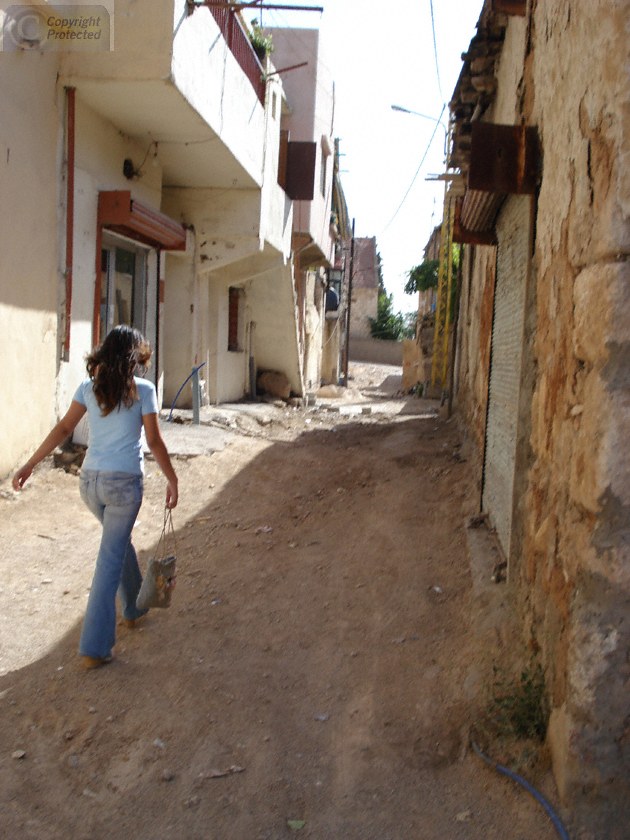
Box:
left=468, top=122, right=539, bottom=195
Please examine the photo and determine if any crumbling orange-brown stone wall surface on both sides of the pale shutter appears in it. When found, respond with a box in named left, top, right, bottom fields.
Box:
left=457, top=0, right=630, bottom=820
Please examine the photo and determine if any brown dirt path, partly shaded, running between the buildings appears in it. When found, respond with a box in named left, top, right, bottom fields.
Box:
left=0, top=368, right=572, bottom=840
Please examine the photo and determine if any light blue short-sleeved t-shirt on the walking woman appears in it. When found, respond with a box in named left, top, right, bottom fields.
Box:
left=74, top=376, right=158, bottom=475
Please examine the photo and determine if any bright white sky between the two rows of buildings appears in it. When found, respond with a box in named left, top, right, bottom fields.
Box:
left=260, top=0, right=483, bottom=312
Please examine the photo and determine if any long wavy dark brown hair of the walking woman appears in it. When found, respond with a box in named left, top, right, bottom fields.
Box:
left=86, top=324, right=151, bottom=417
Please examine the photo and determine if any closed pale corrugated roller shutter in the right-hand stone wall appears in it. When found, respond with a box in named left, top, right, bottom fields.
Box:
left=483, top=196, right=531, bottom=557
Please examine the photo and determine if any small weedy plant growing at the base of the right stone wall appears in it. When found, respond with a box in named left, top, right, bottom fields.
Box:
left=491, top=660, right=549, bottom=743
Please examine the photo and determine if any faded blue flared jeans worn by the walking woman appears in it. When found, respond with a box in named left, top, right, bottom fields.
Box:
left=79, top=470, right=146, bottom=658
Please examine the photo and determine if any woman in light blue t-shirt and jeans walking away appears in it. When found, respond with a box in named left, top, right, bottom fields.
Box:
left=13, top=325, right=177, bottom=668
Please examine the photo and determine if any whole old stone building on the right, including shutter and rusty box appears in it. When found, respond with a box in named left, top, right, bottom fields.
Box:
left=450, top=0, right=630, bottom=838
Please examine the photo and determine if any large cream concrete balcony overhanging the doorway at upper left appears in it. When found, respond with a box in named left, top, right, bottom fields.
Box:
left=56, top=0, right=265, bottom=190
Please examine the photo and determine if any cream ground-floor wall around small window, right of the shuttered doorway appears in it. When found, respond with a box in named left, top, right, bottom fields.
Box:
left=162, top=182, right=300, bottom=403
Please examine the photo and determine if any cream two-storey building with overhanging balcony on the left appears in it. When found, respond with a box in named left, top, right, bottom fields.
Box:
left=0, top=0, right=324, bottom=475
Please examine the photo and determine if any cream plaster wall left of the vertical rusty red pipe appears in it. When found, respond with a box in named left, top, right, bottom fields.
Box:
left=0, top=53, right=61, bottom=477
